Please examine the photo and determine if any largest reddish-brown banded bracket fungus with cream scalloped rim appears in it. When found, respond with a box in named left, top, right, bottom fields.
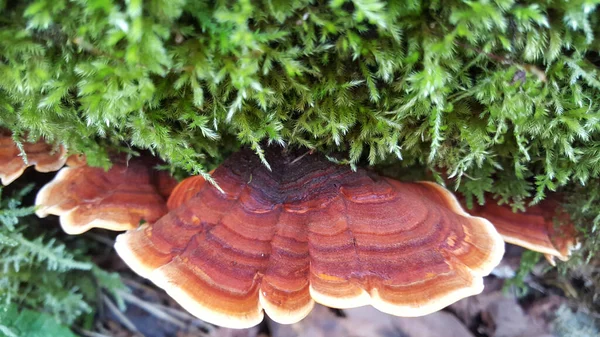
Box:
left=115, top=148, right=504, bottom=328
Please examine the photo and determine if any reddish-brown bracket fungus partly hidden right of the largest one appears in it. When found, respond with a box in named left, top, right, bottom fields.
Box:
left=470, top=195, right=578, bottom=265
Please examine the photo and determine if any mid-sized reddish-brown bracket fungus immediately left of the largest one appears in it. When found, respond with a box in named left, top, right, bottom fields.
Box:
left=35, top=156, right=177, bottom=234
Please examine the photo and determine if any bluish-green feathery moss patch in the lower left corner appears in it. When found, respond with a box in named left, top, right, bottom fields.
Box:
left=0, top=185, right=125, bottom=337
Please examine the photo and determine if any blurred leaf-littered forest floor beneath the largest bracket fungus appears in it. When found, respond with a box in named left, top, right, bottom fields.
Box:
left=72, top=234, right=600, bottom=337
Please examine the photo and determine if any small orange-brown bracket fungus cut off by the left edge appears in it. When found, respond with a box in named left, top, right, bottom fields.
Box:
left=0, top=129, right=67, bottom=185
